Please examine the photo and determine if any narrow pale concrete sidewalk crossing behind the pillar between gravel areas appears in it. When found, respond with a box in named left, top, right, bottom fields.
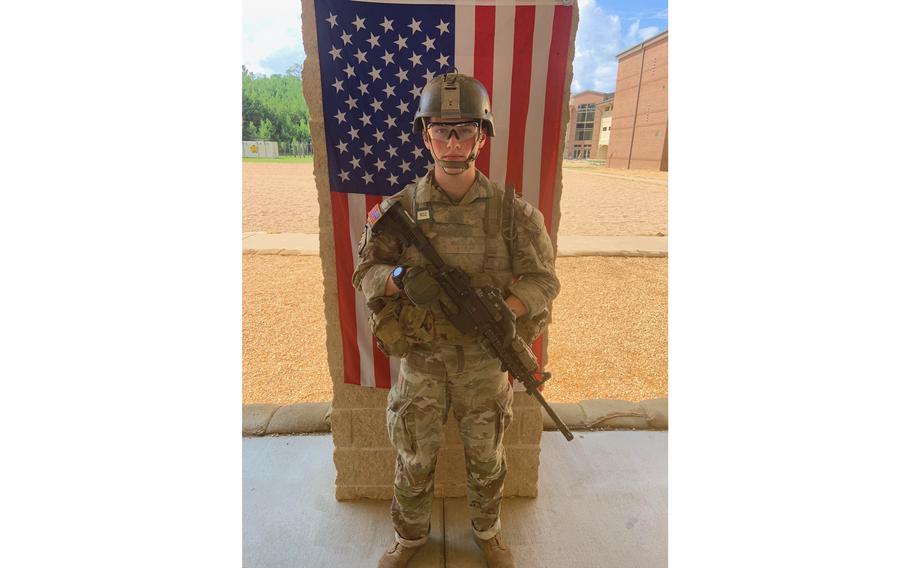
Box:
left=243, top=232, right=667, bottom=257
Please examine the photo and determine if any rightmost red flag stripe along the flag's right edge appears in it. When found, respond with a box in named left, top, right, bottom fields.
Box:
left=537, top=6, right=572, bottom=235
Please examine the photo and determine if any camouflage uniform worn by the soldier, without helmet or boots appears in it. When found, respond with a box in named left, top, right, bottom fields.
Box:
left=353, top=172, right=559, bottom=546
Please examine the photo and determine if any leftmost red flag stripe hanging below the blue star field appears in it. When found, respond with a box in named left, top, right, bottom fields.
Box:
left=329, top=191, right=360, bottom=385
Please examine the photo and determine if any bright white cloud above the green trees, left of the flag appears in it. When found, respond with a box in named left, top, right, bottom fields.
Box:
left=243, top=0, right=303, bottom=74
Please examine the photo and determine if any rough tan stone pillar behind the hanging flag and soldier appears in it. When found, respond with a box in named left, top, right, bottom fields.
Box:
left=301, top=0, right=578, bottom=500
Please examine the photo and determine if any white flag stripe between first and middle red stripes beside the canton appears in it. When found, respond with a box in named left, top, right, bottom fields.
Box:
left=490, top=6, right=515, bottom=187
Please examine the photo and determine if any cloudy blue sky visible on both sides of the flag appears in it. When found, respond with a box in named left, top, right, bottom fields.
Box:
left=243, top=0, right=668, bottom=93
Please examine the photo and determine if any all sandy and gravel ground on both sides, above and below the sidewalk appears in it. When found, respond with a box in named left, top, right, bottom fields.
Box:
left=243, top=163, right=668, bottom=404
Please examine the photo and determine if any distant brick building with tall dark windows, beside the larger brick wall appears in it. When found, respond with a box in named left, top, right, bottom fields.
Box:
left=563, top=91, right=613, bottom=160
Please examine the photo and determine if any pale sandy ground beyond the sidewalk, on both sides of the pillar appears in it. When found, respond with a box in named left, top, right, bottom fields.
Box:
left=243, top=162, right=667, bottom=236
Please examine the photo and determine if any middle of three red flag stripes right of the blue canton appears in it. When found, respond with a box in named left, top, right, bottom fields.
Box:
left=506, top=6, right=534, bottom=195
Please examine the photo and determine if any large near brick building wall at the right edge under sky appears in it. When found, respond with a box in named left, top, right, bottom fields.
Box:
left=607, top=31, right=669, bottom=171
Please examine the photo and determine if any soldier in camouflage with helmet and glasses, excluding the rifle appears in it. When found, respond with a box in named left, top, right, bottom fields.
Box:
left=353, top=73, right=559, bottom=568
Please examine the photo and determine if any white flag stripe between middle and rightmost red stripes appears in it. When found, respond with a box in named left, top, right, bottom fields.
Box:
left=521, top=6, right=553, bottom=211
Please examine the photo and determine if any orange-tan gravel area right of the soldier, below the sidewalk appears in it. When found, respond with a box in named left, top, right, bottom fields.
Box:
left=544, top=256, right=668, bottom=402
